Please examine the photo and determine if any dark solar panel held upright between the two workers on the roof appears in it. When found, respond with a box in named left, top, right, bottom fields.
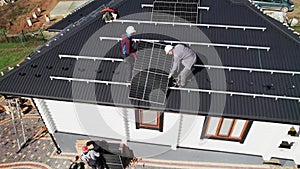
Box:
left=129, top=42, right=173, bottom=104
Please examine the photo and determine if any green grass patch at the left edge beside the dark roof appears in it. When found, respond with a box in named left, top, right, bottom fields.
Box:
left=0, top=41, right=43, bottom=72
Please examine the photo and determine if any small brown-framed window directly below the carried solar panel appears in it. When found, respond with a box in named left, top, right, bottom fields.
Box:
left=135, top=109, right=164, bottom=132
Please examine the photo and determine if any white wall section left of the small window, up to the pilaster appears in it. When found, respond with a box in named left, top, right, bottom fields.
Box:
left=40, top=100, right=126, bottom=140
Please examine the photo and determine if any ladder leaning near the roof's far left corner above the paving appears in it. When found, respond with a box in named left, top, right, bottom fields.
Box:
left=8, top=99, right=27, bottom=153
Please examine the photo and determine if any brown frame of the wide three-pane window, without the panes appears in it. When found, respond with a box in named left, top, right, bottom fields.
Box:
left=200, top=117, right=253, bottom=144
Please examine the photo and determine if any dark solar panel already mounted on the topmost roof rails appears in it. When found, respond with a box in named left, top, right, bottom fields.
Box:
left=152, top=2, right=198, bottom=24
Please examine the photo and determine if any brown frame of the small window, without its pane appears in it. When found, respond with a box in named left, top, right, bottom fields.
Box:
left=135, top=109, right=164, bottom=132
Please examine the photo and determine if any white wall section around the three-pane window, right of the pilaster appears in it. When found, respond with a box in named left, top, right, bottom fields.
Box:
left=179, top=115, right=300, bottom=164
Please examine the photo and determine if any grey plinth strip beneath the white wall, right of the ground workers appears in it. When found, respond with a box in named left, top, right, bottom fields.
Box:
left=128, top=142, right=263, bottom=165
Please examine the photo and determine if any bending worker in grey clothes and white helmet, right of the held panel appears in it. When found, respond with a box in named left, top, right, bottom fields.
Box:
left=165, top=44, right=197, bottom=87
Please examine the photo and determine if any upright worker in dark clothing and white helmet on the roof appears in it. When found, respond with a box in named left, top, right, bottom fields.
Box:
left=120, top=26, right=137, bottom=82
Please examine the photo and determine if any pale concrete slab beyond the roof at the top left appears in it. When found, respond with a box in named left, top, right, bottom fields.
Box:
left=50, top=0, right=87, bottom=18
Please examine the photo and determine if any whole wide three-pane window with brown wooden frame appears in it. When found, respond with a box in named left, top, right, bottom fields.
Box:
left=201, top=117, right=251, bottom=143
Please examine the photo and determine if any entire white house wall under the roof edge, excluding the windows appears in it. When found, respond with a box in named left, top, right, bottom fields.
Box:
left=37, top=100, right=300, bottom=164
